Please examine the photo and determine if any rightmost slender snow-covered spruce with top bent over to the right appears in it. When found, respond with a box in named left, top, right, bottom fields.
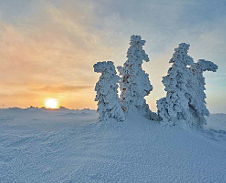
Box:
left=189, top=59, right=218, bottom=128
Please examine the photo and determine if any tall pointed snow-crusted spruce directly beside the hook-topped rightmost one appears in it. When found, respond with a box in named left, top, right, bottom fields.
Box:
left=157, top=43, right=193, bottom=128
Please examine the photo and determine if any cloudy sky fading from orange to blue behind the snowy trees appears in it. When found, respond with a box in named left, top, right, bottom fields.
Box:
left=0, top=0, right=226, bottom=113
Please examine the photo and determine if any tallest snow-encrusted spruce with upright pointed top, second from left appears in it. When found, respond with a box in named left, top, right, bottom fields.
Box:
left=118, top=35, right=156, bottom=119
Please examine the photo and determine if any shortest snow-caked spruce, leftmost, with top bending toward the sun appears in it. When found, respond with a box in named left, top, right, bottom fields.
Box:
left=93, top=61, right=125, bottom=121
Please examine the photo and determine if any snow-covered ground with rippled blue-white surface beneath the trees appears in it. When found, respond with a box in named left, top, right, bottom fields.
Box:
left=0, top=108, right=226, bottom=183
